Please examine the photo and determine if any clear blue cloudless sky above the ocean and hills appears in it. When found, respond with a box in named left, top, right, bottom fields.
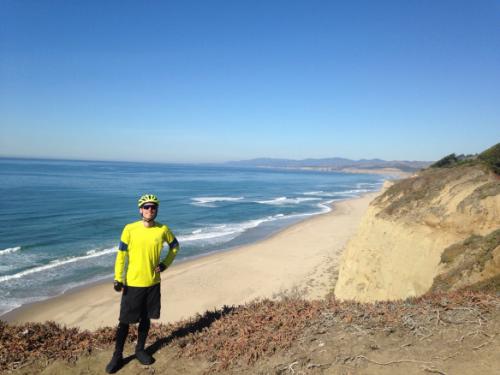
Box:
left=0, top=0, right=500, bottom=162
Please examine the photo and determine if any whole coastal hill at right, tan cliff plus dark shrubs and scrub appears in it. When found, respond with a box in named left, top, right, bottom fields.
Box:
left=335, top=144, right=500, bottom=302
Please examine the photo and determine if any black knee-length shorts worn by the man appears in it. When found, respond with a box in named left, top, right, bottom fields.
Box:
left=120, top=283, right=161, bottom=324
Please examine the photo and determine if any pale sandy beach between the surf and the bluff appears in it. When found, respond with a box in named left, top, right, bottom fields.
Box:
left=1, top=193, right=378, bottom=329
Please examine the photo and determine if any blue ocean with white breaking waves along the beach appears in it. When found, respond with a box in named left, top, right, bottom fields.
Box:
left=0, top=158, right=386, bottom=315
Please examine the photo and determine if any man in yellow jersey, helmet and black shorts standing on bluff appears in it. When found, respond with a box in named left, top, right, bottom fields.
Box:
left=106, top=194, right=179, bottom=374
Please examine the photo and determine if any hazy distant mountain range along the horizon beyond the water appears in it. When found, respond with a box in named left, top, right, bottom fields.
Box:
left=225, top=158, right=431, bottom=172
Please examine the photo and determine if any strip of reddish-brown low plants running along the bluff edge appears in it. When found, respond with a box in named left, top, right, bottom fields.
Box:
left=0, top=291, right=500, bottom=372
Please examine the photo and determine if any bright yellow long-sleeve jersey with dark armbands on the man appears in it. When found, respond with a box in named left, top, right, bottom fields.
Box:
left=115, top=220, right=179, bottom=287
